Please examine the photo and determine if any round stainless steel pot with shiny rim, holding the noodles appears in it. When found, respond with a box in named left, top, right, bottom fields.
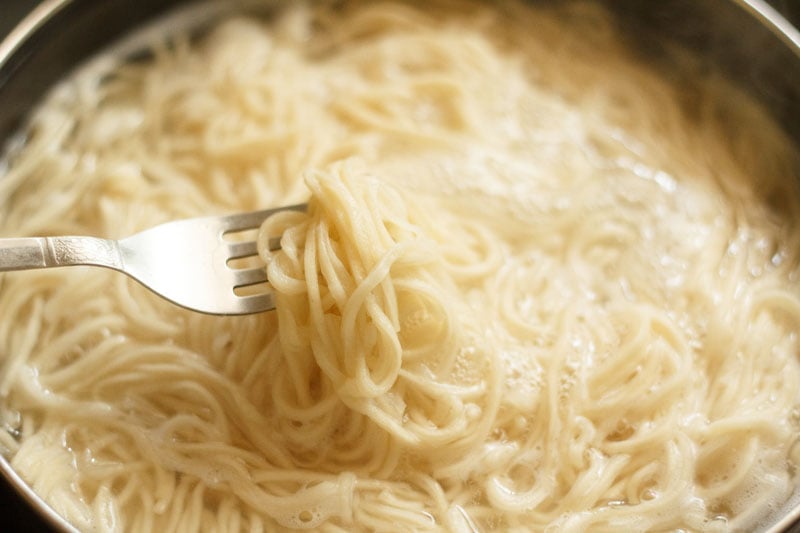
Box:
left=0, top=0, right=800, bottom=533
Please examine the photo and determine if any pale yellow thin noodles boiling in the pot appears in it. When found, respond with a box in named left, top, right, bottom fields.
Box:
left=0, top=0, right=800, bottom=532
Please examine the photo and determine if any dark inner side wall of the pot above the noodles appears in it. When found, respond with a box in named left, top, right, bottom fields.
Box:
left=0, top=0, right=800, bottom=530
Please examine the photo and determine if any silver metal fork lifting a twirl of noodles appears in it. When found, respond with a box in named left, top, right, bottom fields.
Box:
left=0, top=204, right=306, bottom=315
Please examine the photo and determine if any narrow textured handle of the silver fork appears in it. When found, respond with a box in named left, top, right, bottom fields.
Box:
left=0, top=237, right=122, bottom=272
